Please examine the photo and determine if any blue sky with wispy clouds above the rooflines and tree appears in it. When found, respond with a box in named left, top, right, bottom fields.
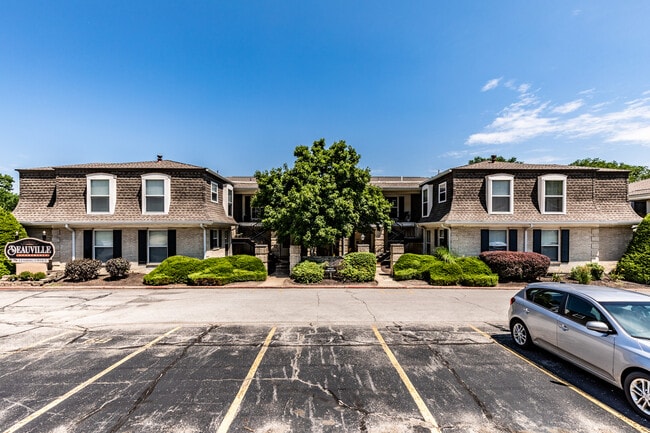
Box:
left=0, top=0, right=650, bottom=179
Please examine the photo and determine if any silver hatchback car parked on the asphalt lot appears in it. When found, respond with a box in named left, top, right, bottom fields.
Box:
left=508, top=283, right=650, bottom=419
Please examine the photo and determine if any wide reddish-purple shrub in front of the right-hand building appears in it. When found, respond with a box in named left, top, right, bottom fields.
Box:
left=479, top=251, right=551, bottom=281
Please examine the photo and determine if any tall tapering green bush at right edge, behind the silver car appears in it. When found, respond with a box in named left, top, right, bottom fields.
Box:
left=615, top=214, right=650, bottom=284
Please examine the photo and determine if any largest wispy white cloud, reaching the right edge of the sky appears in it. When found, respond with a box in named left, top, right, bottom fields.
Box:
left=466, top=83, right=650, bottom=146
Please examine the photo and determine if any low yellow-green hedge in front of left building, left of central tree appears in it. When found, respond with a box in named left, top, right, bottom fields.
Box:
left=143, top=255, right=267, bottom=286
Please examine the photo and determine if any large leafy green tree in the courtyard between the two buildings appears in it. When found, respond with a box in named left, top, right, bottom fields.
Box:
left=253, top=139, right=392, bottom=248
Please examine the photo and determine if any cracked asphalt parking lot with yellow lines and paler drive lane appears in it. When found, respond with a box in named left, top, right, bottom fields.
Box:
left=0, top=289, right=649, bottom=433
